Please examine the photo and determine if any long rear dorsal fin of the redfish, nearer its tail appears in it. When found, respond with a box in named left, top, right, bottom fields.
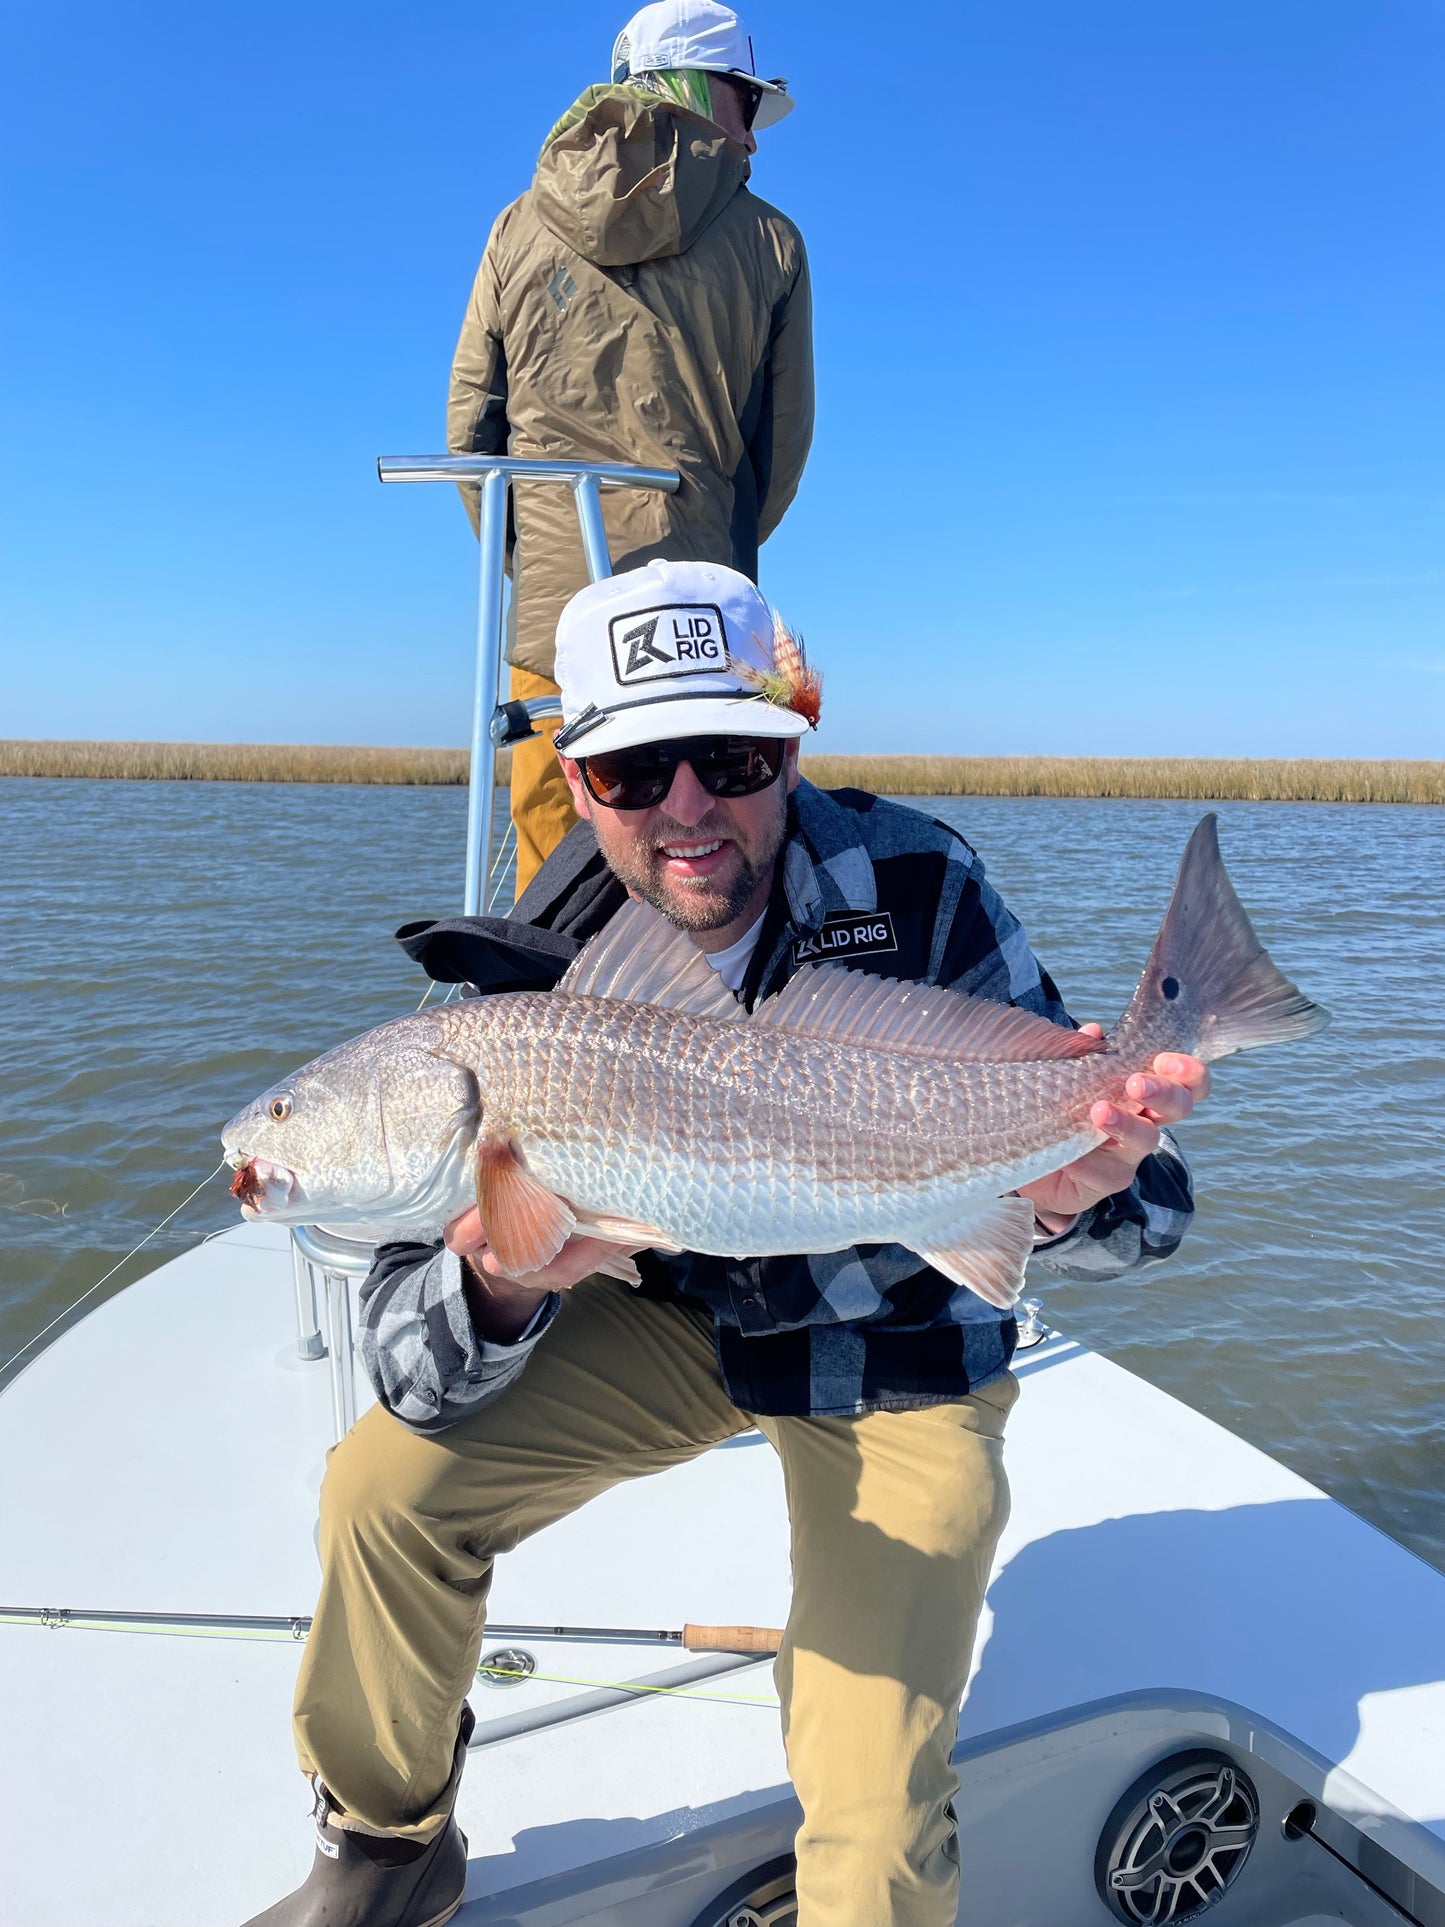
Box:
left=751, top=964, right=1104, bottom=1064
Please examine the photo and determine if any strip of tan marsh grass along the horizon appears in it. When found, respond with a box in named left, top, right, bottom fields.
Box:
left=0, top=738, right=1445, bottom=804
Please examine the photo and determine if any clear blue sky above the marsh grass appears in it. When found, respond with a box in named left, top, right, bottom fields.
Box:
left=0, top=0, right=1445, bottom=757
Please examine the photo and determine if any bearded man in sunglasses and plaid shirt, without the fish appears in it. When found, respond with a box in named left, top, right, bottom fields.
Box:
left=252, top=561, right=1208, bottom=1927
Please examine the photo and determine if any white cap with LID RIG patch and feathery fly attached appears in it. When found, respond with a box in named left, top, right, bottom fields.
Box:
left=555, top=561, right=809, bottom=755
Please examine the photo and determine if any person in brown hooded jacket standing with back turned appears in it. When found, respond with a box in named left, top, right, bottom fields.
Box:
left=447, top=0, right=813, bottom=894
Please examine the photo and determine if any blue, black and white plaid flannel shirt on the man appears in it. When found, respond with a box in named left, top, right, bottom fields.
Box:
left=362, top=782, right=1193, bottom=1432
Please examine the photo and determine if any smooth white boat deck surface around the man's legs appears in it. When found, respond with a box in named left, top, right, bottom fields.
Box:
left=0, top=1226, right=1445, bottom=1927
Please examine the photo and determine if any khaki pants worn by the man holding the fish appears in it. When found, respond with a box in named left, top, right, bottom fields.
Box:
left=297, top=1280, right=1017, bottom=1927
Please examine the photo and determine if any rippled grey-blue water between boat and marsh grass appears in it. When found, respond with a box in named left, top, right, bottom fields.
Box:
left=0, top=779, right=1445, bottom=1569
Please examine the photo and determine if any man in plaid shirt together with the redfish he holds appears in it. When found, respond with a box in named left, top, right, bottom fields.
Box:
left=235, top=543, right=1324, bottom=1927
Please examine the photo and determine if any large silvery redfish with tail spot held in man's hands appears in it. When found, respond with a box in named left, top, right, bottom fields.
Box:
left=222, top=815, right=1327, bottom=1307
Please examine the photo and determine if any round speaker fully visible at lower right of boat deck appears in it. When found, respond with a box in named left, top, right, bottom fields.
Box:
left=1094, top=1748, right=1260, bottom=1923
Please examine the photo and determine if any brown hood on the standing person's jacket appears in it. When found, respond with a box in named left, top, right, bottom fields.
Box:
left=532, top=87, right=751, bottom=268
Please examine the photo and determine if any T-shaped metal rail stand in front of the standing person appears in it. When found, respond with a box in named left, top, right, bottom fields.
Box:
left=376, top=455, right=680, bottom=917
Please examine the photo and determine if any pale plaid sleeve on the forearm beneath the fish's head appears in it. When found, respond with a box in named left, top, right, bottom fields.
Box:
left=360, top=1245, right=561, bottom=1434
